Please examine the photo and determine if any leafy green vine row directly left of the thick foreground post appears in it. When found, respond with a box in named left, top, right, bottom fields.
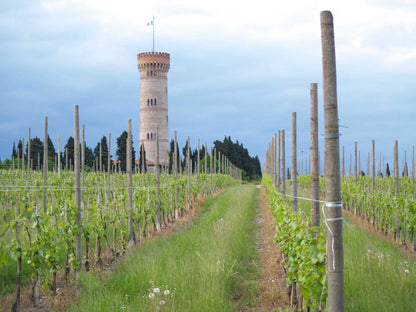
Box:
left=262, top=174, right=328, bottom=311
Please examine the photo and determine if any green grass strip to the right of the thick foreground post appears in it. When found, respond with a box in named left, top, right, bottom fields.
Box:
left=287, top=183, right=416, bottom=312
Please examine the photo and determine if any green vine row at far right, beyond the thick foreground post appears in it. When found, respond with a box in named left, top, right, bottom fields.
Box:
left=298, top=175, right=416, bottom=250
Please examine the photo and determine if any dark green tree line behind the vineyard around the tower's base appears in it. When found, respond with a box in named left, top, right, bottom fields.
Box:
left=0, top=131, right=262, bottom=181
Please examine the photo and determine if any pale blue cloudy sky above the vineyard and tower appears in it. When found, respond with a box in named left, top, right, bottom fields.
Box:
left=0, top=0, right=416, bottom=170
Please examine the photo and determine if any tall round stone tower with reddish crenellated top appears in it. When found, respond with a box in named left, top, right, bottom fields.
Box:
left=137, top=52, right=170, bottom=170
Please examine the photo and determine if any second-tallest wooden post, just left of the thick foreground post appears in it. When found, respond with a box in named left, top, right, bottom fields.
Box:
left=310, top=83, right=320, bottom=227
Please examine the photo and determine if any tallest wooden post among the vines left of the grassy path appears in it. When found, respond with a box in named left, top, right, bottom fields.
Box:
left=74, top=105, right=82, bottom=270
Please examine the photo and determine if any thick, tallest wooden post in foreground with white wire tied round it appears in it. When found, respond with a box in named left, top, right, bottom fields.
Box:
left=321, top=11, right=344, bottom=312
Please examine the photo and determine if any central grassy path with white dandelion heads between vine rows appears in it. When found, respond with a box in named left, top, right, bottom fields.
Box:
left=69, top=186, right=259, bottom=311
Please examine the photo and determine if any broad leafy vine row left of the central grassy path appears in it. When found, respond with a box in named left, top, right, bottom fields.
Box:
left=0, top=170, right=237, bottom=304
